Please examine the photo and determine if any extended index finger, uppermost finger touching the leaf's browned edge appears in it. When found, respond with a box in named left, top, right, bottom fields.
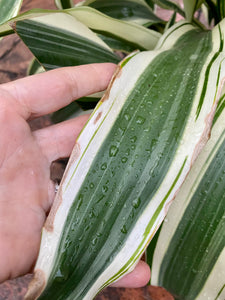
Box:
left=1, top=63, right=116, bottom=119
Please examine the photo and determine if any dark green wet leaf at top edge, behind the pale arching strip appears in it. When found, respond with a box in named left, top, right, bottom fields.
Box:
left=76, top=0, right=163, bottom=25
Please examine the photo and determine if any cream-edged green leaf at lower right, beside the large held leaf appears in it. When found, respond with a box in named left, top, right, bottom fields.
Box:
left=151, top=95, right=225, bottom=300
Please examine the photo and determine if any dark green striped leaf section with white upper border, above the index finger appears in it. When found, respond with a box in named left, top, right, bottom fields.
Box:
left=15, top=12, right=120, bottom=70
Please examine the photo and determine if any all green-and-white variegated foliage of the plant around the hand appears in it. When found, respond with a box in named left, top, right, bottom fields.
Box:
left=0, top=0, right=225, bottom=300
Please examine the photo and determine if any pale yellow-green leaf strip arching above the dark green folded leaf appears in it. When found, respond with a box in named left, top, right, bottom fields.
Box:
left=0, top=7, right=161, bottom=50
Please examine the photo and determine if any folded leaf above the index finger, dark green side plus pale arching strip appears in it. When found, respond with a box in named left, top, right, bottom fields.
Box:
left=9, top=7, right=161, bottom=69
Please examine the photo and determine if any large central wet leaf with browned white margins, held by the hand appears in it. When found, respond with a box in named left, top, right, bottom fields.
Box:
left=26, top=19, right=224, bottom=300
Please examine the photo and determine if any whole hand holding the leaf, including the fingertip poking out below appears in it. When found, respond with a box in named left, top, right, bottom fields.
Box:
left=0, top=63, right=150, bottom=287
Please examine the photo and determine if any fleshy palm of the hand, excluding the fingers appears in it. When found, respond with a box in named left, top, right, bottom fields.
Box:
left=0, top=96, right=53, bottom=280
